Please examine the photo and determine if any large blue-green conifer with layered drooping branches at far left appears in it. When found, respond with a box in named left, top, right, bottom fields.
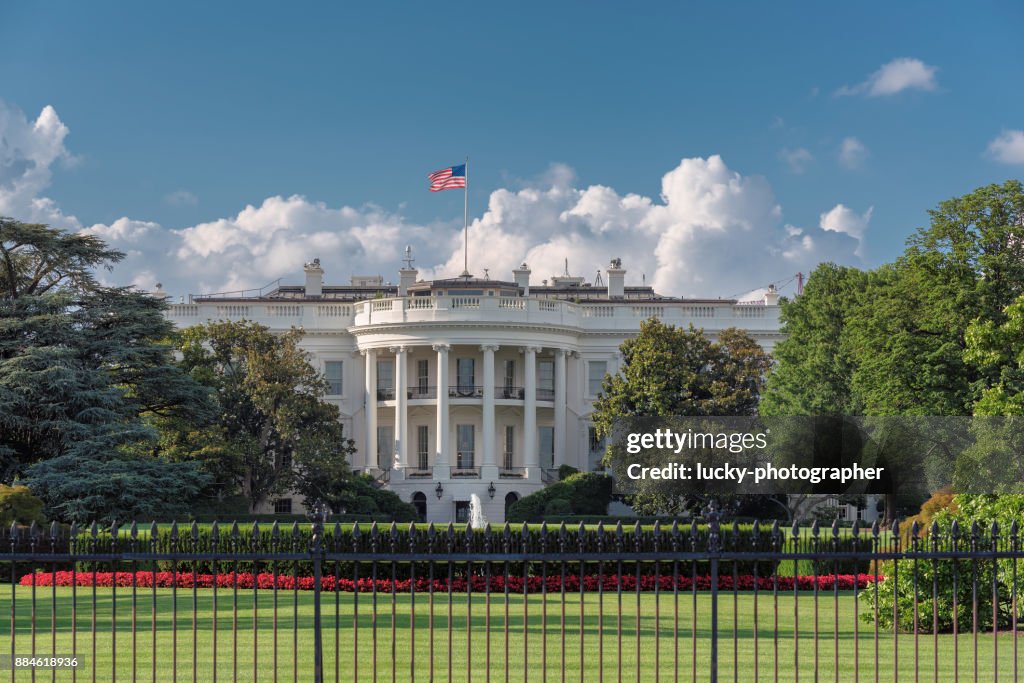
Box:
left=0, top=218, right=212, bottom=521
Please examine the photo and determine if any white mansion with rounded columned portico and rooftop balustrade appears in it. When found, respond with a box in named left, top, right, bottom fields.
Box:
left=168, top=255, right=781, bottom=522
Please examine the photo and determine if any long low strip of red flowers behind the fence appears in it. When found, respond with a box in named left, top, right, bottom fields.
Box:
left=19, top=571, right=883, bottom=593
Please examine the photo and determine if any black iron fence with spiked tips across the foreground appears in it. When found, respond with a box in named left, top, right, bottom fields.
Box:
left=0, top=513, right=1022, bottom=682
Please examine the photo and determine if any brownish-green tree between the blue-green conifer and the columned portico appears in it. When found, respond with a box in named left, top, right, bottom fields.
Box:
left=171, top=321, right=353, bottom=509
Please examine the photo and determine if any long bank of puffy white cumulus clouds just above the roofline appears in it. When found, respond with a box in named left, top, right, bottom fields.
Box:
left=0, top=102, right=871, bottom=297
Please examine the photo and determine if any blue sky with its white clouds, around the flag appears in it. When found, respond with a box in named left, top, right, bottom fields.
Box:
left=0, top=2, right=1024, bottom=296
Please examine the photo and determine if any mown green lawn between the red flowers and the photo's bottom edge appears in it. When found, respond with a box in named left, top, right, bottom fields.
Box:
left=0, top=587, right=1024, bottom=683
